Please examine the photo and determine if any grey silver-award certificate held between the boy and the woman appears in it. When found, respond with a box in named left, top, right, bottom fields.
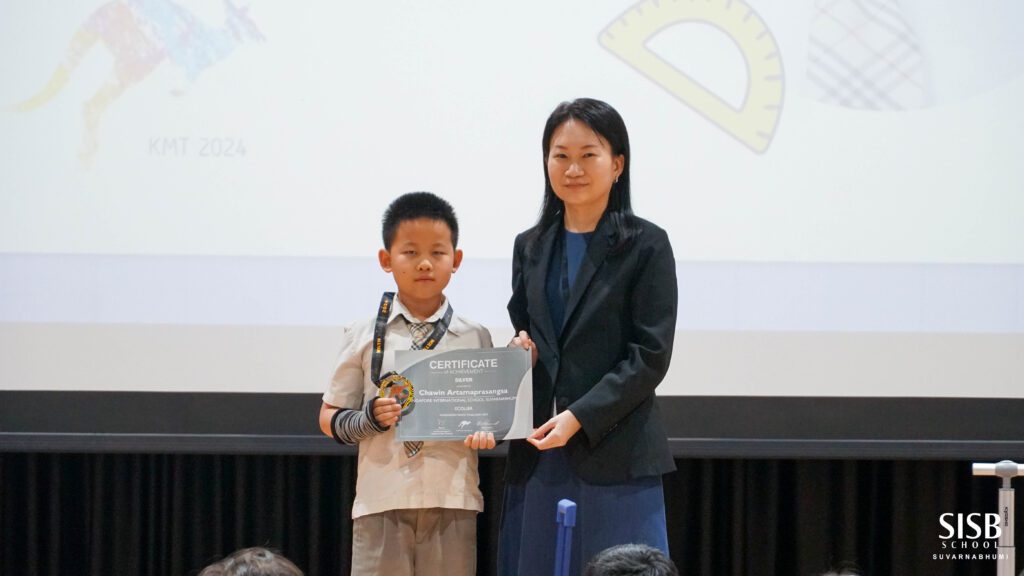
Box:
left=394, top=348, right=534, bottom=441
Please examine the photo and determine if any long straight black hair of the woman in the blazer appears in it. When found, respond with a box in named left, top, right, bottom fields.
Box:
left=527, top=98, right=638, bottom=251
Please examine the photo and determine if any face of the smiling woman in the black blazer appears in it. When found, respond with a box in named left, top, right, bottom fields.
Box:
left=548, top=118, right=625, bottom=211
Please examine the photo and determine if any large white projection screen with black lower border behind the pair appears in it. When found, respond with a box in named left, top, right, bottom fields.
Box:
left=0, top=0, right=1024, bottom=457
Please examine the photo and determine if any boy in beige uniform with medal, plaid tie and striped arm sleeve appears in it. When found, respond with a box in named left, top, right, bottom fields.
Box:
left=319, top=192, right=495, bottom=576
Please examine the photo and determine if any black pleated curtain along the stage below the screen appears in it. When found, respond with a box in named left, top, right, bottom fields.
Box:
left=0, top=453, right=1007, bottom=576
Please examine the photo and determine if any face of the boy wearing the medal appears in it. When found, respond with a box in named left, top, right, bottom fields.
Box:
left=378, top=218, right=462, bottom=304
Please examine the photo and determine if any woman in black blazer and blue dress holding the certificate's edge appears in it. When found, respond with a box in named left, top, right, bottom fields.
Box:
left=499, top=98, right=677, bottom=576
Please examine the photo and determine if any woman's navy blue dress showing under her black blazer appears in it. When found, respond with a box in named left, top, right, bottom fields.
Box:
left=498, top=231, right=669, bottom=576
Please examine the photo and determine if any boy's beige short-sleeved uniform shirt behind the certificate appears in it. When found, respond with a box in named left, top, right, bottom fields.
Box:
left=324, top=297, right=493, bottom=519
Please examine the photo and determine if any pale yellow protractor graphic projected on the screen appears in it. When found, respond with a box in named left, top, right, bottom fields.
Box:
left=598, top=0, right=785, bottom=154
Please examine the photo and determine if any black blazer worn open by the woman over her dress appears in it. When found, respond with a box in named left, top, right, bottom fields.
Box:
left=506, top=213, right=677, bottom=484
